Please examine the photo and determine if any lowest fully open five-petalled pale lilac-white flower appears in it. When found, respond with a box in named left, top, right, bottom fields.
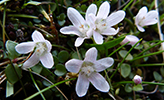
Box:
left=65, top=47, right=114, bottom=97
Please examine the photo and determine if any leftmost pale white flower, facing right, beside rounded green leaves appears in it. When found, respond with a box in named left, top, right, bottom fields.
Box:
left=15, top=31, right=54, bottom=68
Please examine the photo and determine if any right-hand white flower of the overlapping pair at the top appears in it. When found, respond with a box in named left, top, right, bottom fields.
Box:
left=86, top=1, right=125, bottom=44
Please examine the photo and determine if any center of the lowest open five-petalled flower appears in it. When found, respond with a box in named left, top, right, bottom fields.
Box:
left=81, top=62, right=95, bottom=77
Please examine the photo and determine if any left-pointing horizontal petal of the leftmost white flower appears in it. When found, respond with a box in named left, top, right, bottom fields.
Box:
left=15, top=42, right=35, bottom=54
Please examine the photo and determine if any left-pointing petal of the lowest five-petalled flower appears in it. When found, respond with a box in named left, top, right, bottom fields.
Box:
left=65, top=59, right=83, bottom=73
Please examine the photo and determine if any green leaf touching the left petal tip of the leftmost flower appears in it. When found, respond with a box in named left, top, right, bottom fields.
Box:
left=6, top=40, right=20, bottom=59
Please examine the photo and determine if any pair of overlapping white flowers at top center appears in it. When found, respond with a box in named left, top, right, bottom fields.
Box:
left=60, top=1, right=125, bottom=47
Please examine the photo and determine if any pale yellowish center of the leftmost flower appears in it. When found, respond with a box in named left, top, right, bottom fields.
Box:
left=35, top=42, right=48, bottom=57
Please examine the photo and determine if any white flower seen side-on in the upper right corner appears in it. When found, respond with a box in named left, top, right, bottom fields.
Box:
left=135, top=6, right=158, bottom=32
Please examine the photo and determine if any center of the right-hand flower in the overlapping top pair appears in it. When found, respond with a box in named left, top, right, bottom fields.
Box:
left=95, top=19, right=107, bottom=33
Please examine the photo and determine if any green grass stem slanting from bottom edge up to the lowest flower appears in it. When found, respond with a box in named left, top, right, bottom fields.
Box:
left=24, top=78, right=76, bottom=100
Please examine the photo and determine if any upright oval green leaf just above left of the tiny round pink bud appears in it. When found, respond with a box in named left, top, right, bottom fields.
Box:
left=121, top=63, right=131, bottom=78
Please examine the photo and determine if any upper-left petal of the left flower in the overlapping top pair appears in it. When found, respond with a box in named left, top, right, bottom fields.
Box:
left=67, top=7, right=85, bottom=28
